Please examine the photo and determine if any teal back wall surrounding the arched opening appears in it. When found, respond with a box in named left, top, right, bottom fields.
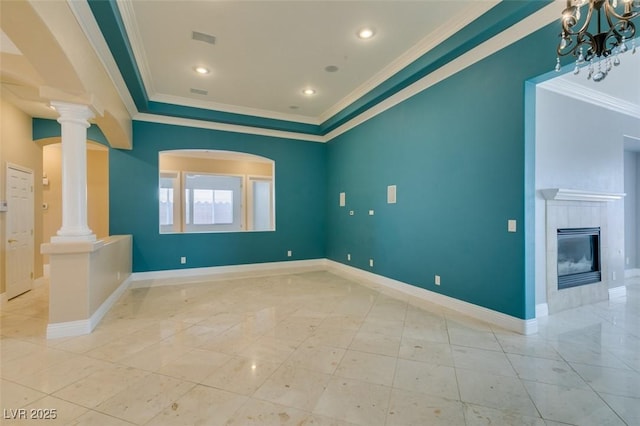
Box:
left=109, top=121, right=327, bottom=272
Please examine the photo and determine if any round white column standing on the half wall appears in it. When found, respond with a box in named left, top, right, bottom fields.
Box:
left=51, top=102, right=96, bottom=242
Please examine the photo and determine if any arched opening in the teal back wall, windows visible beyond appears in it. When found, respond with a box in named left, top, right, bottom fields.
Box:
left=158, top=150, right=275, bottom=233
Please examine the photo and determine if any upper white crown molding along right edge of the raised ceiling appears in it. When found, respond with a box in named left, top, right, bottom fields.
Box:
left=318, top=1, right=499, bottom=123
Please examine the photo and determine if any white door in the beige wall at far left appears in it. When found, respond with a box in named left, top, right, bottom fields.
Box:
left=5, top=165, right=34, bottom=299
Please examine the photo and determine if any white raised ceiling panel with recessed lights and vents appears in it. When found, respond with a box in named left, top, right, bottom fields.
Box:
left=118, top=1, right=498, bottom=123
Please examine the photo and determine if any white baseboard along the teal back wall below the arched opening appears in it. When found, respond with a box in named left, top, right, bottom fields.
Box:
left=131, top=259, right=326, bottom=288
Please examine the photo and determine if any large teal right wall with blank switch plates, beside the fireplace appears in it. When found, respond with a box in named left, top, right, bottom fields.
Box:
left=327, top=21, right=557, bottom=319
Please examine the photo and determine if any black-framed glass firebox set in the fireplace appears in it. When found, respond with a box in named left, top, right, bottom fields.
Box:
left=558, top=227, right=602, bottom=290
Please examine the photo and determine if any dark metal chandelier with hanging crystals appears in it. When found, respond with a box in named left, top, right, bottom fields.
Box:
left=556, top=0, right=640, bottom=81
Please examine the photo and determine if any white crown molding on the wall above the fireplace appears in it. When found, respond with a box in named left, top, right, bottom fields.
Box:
left=539, top=78, right=640, bottom=118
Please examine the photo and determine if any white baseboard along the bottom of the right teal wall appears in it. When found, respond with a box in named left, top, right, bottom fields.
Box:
left=326, top=260, right=538, bottom=335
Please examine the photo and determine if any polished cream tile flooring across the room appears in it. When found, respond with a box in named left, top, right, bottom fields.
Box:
left=0, top=271, right=640, bottom=426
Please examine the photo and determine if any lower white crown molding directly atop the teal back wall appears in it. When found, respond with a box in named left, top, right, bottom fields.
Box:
left=133, top=113, right=327, bottom=143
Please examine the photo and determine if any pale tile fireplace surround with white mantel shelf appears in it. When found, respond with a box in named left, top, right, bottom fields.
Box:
left=541, top=188, right=625, bottom=314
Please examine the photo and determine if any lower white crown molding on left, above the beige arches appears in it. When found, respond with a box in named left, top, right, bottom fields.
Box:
left=67, top=0, right=138, bottom=116
